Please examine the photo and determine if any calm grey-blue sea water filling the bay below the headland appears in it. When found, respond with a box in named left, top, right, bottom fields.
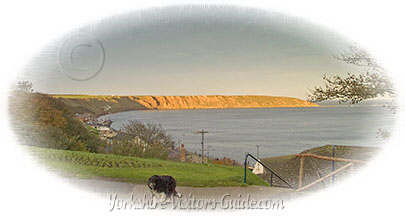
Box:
left=103, top=106, right=395, bottom=161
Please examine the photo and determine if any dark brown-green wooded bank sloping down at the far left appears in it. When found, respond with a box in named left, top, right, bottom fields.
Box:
left=9, top=83, right=105, bottom=152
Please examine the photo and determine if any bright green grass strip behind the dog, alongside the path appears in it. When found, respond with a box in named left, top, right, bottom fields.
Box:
left=27, top=147, right=268, bottom=187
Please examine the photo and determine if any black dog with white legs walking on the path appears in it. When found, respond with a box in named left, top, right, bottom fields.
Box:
left=148, top=175, right=181, bottom=201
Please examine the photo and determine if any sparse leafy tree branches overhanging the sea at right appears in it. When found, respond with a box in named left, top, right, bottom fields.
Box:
left=308, top=46, right=395, bottom=104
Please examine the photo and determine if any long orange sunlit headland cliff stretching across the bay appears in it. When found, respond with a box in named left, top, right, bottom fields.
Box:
left=52, top=95, right=318, bottom=116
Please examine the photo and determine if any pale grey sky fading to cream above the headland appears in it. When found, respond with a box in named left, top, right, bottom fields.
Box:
left=18, top=6, right=359, bottom=99
